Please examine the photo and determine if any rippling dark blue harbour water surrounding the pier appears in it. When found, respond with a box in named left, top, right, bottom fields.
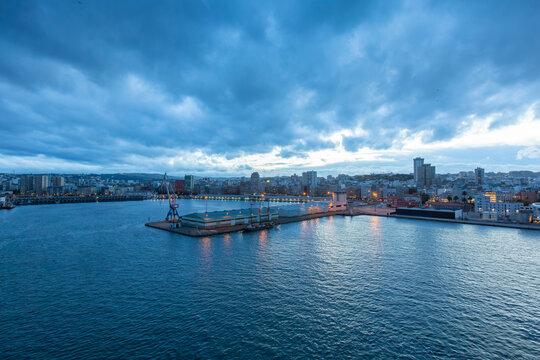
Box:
left=0, top=200, right=540, bottom=359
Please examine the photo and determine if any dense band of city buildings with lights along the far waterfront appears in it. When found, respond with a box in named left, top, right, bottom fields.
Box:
left=0, top=157, right=540, bottom=221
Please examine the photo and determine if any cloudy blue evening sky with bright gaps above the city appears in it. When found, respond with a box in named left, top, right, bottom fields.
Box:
left=0, top=0, right=540, bottom=176
